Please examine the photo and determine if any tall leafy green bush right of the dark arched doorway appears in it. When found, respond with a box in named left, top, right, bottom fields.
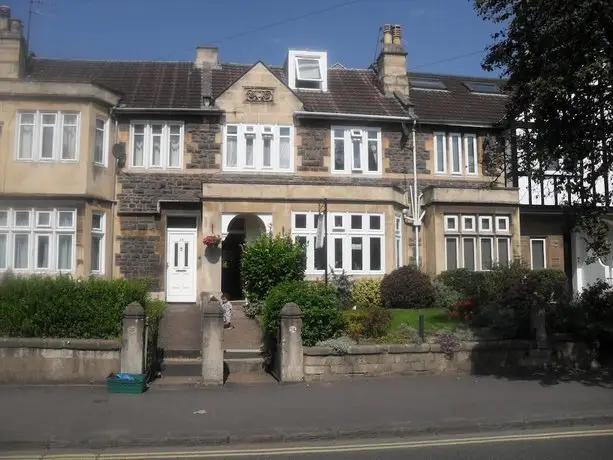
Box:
left=241, top=233, right=306, bottom=302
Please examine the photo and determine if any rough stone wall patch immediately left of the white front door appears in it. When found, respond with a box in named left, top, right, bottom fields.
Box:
left=115, top=215, right=164, bottom=292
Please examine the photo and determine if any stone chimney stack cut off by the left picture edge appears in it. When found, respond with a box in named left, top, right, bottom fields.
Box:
left=0, top=6, right=27, bottom=79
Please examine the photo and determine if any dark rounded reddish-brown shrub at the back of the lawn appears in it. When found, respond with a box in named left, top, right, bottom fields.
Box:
left=381, top=265, right=435, bottom=308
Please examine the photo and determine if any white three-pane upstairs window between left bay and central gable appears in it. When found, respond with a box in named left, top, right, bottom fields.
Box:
left=130, top=121, right=183, bottom=169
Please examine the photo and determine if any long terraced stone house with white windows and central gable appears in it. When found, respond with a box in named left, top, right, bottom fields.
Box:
left=0, top=8, right=596, bottom=302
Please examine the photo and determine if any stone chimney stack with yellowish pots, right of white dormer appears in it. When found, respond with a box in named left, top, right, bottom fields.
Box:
left=377, top=24, right=409, bottom=101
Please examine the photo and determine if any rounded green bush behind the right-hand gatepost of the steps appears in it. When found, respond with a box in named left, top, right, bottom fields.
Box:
left=262, top=281, right=345, bottom=347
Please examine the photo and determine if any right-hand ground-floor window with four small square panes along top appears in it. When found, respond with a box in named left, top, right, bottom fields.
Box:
left=443, top=214, right=511, bottom=270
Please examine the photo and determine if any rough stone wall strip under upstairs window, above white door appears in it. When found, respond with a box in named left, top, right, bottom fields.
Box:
left=117, top=172, right=202, bottom=213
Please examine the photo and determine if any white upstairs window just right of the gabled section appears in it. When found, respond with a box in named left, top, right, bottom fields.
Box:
left=332, top=127, right=382, bottom=174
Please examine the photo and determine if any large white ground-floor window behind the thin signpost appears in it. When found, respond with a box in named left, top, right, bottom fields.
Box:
left=292, top=212, right=382, bottom=275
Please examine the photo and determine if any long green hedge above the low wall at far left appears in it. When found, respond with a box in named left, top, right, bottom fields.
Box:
left=0, top=276, right=152, bottom=339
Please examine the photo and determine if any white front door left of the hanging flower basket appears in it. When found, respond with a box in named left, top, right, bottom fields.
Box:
left=166, top=230, right=196, bottom=302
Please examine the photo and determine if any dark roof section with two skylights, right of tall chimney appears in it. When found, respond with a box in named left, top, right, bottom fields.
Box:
left=409, top=72, right=508, bottom=125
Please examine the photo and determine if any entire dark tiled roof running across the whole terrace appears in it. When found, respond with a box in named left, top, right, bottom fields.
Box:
left=27, top=58, right=507, bottom=125
